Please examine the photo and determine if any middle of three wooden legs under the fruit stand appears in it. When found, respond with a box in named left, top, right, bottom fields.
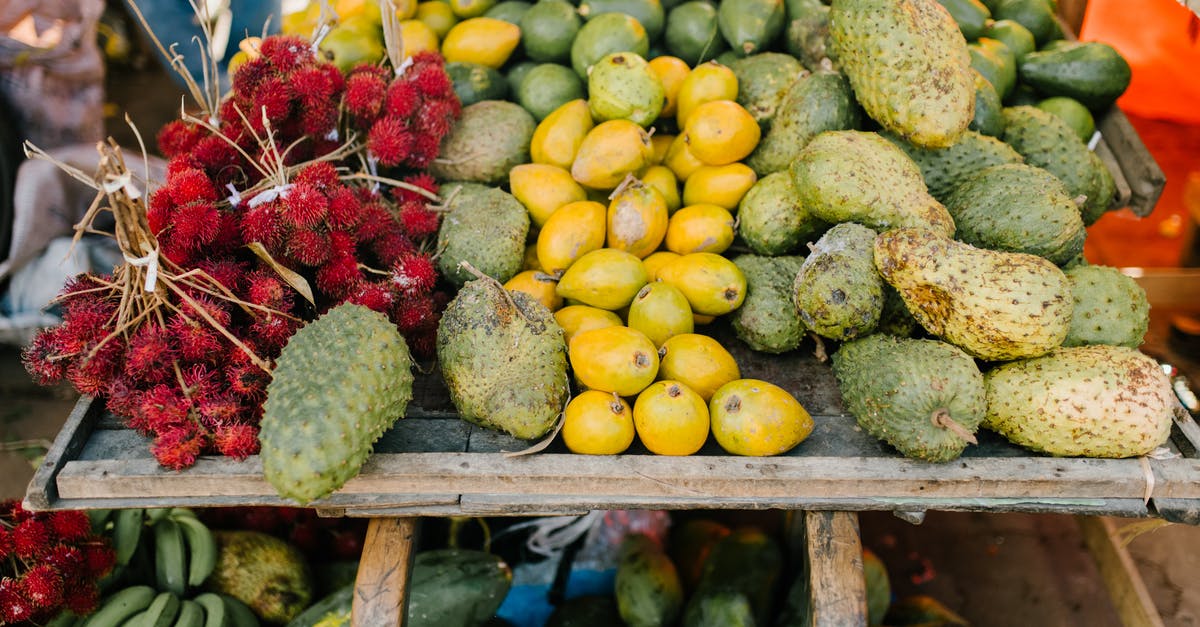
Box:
left=788, top=512, right=866, bottom=627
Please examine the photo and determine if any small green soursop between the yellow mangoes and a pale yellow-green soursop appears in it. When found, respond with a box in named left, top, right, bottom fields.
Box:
left=737, top=172, right=829, bottom=255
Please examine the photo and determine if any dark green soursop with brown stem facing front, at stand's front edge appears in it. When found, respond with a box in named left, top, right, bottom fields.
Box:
left=833, top=334, right=988, bottom=461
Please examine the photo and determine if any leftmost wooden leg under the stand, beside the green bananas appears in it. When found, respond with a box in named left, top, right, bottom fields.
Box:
left=350, top=518, right=418, bottom=627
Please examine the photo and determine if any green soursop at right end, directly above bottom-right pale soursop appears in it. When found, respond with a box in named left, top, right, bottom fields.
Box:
left=1062, top=265, right=1150, bottom=348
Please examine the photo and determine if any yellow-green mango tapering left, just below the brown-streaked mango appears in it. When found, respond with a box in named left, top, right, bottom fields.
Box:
left=558, top=249, right=646, bottom=311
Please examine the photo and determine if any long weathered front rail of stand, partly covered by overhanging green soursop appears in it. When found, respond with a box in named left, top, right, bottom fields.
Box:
left=58, top=453, right=1200, bottom=504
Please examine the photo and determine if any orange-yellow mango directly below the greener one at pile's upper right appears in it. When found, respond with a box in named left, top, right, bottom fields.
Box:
left=683, top=100, right=762, bottom=166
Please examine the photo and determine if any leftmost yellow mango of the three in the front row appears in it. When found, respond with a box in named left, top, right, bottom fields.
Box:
left=563, top=389, right=638, bottom=455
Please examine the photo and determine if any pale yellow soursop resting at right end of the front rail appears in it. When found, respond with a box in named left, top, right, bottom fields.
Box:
left=984, top=345, right=1178, bottom=458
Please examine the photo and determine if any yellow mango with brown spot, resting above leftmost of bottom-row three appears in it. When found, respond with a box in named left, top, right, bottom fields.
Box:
left=566, top=327, right=659, bottom=396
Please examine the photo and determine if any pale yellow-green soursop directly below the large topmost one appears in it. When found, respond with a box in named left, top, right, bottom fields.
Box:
left=788, top=131, right=954, bottom=237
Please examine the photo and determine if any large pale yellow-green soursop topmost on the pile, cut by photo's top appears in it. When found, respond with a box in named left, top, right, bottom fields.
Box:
left=829, top=0, right=974, bottom=148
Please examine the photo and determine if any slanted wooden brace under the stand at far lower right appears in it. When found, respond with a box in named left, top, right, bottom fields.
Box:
left=1075, top=516, right=1163, bottom=627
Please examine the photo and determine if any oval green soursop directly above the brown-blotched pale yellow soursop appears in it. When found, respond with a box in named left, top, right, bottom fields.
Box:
left=944, top=163, right=1087, bottom=267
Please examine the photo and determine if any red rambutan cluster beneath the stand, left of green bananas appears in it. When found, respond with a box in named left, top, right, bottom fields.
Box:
left=0, top=501, right=116, bottom=625
